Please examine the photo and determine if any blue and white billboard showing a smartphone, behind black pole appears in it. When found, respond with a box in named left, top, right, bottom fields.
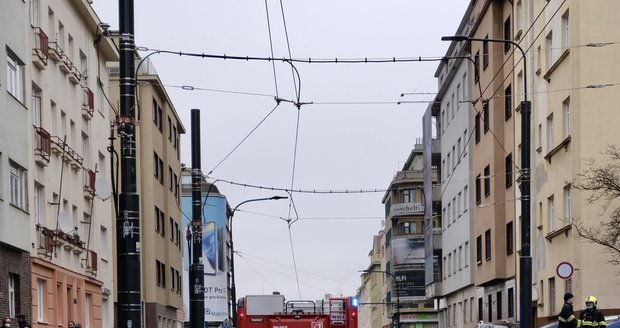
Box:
left=181, top=193, right=229, bottom=322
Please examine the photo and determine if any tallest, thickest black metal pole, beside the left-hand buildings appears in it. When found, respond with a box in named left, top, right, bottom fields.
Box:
left=116, top=0, right=142, bottom=328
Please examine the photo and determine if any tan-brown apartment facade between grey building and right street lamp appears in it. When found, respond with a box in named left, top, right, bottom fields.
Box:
left=468, top=1, right=518, bottom=322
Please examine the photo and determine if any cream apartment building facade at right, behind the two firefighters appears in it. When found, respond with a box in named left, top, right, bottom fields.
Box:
left=515, top=1, right=620, bottom=324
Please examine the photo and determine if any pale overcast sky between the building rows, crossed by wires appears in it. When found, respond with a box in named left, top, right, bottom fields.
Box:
left=93, top=0, right=469, bottom=299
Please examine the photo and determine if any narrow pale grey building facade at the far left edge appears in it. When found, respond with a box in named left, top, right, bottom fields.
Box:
left=0, top=1, right=32, bottom=320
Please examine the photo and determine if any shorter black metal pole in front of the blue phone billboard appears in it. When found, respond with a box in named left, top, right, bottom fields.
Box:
left=189, top=109, right=205, bottom=328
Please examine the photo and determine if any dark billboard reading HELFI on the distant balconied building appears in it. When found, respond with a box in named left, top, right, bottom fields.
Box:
left=391, top=237, right=426, bottom=299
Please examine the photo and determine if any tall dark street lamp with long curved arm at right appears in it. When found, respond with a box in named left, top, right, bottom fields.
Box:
left=441, top=35, right=533, bottom=328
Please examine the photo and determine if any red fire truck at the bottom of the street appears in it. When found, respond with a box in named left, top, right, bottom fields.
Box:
left=237, top=294, right=358, bottom=328
